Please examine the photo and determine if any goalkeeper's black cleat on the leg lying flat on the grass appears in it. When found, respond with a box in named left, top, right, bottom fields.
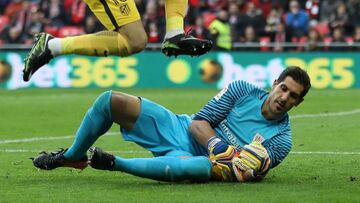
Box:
left=89, top=147, right=115, bottom=171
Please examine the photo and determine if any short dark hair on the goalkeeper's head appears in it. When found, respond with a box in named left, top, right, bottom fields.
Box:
left=277, top=66, right=311, bottom=99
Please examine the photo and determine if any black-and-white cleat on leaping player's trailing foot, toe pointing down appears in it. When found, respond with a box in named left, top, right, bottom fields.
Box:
left=23, top=32, right=54, bottom=81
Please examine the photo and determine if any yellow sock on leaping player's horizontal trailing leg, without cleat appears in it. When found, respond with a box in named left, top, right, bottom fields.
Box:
left=54, top=31, right=132, bottom=56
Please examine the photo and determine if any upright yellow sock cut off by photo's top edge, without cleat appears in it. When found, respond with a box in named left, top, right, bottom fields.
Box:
left=165, top=0, right=188, bottom=39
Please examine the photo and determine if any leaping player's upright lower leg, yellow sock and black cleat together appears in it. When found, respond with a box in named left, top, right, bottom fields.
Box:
left=162, top=0, right=213, bottom=56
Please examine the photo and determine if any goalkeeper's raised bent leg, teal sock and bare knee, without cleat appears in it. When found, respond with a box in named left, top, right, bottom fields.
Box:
left=64, top=91, right=140, bottom=160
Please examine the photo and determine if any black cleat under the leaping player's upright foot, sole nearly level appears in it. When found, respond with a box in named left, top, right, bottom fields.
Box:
left=161, top=34, right=213, bottom=57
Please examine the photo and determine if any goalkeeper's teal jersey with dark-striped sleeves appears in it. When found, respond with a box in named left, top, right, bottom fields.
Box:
left=194, top=80, right=292, bottom=168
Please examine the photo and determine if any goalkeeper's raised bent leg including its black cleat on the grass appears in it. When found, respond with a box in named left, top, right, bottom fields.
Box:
left=33, top=91, right=145, bottom=170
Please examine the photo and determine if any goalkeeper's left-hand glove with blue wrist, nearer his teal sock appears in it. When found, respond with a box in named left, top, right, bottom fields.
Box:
left=207, top=136, right=237, bottom=182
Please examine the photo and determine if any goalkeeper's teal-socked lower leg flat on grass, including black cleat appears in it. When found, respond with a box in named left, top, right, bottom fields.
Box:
left=90, top=148, right=212, bottom=182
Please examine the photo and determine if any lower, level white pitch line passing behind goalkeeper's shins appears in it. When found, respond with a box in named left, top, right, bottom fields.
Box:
left=0, top=149, right=360, bottom=155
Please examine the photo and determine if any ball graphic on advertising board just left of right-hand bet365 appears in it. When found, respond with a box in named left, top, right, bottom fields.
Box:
left=200, top=59, right=223, bottom=83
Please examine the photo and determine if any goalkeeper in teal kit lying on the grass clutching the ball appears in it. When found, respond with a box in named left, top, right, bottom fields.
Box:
left=33, top=67, right=310, bottom=182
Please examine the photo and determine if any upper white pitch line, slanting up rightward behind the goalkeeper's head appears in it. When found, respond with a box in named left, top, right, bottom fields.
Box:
left=0, top=109, right=360, bottom=144
